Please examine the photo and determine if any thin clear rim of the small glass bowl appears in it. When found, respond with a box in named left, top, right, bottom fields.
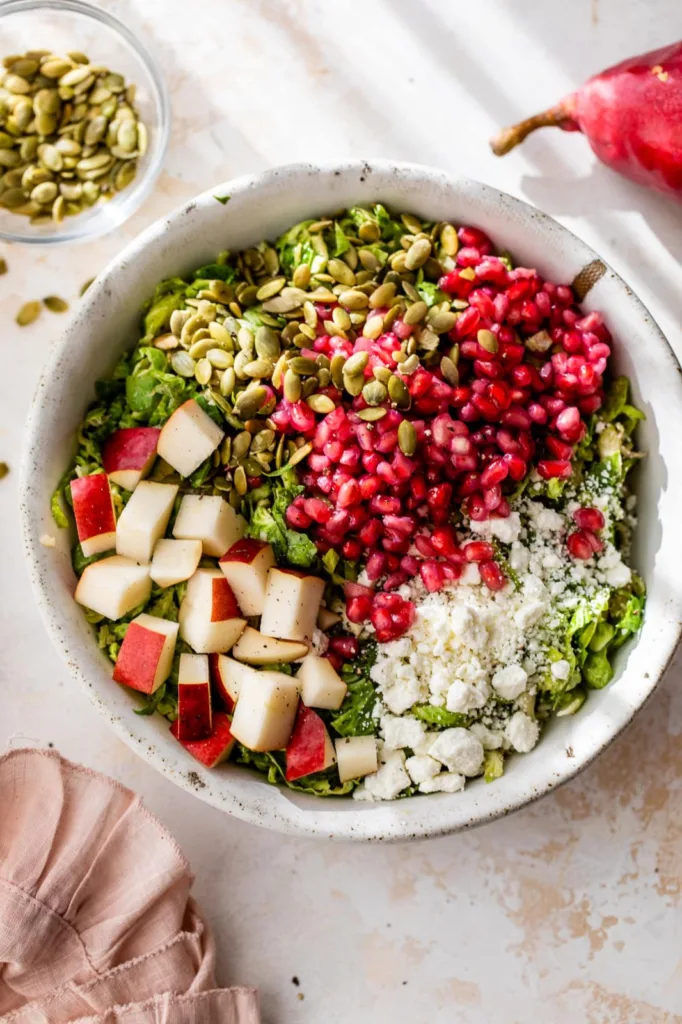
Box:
left=0, top=0, right=171, bottom=246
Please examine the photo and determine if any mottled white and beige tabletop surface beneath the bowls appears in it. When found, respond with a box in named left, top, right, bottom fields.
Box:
left=0, top=0, right=682, bottom=1024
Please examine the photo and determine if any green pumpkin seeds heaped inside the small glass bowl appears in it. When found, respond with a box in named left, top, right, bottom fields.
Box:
left=0, top=50, right=147, bottom=224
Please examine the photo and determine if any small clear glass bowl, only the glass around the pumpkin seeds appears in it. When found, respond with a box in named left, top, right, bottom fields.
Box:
left=0, top=0, right=170, bottom=245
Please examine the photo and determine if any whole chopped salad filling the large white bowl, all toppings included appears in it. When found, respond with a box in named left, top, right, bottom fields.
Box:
left=52, top=202, right=645, bottom=802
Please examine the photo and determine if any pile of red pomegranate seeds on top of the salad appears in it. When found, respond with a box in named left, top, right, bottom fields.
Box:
left=278, top=227, right=610, bottom=640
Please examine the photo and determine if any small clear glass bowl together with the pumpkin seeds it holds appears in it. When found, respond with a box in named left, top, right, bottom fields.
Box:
left=0, top=0, right=170, bottom=245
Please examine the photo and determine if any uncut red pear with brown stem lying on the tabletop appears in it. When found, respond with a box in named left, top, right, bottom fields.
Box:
left=491, top=42, right=682, bottom=200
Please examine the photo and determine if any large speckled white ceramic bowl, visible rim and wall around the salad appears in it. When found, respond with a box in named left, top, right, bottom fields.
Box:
left=22, top=162, right=682, bottom=840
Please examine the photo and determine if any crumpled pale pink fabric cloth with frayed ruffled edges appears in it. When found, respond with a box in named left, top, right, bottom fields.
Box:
left=0, top=750, right=260, bottom=1024
